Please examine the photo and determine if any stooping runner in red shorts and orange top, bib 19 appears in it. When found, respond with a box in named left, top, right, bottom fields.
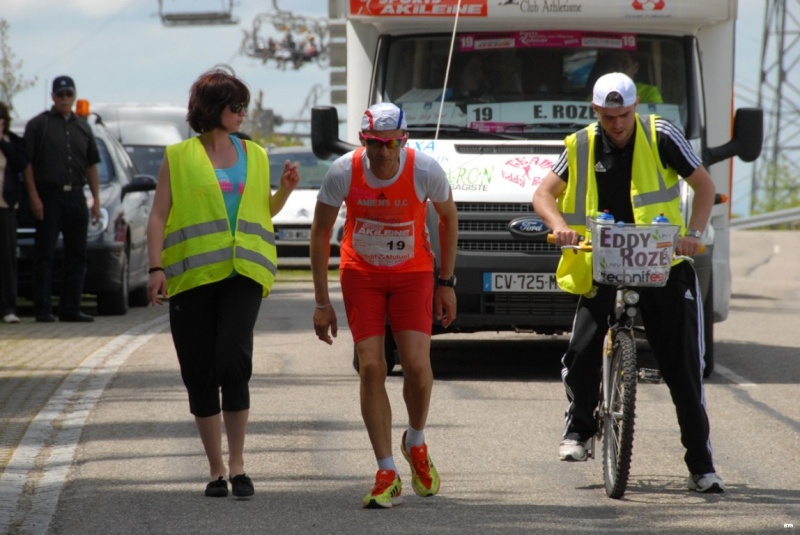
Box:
left=311, top=103, right=458, bottom=508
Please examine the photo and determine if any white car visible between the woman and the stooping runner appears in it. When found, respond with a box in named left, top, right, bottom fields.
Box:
left=267, top=146, right=345, bottom=267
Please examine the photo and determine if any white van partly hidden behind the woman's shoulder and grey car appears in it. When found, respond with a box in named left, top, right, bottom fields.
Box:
left=91, top=103, right=194, bottom=177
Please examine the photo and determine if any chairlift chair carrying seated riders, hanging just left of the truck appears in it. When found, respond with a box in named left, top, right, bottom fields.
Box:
left=239, top=0, right=330, bottom=70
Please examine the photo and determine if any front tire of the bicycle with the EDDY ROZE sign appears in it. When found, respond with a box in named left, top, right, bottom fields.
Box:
left=603, top=330, right=637, bottom=499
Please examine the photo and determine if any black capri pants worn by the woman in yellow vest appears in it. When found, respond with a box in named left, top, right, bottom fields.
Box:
left=169, top=275, right=262, bottom=418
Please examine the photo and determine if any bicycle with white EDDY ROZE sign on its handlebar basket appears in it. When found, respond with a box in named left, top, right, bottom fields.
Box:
left=548, top=219, right=692, bottom=499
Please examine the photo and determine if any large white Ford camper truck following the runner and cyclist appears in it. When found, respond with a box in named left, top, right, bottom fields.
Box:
left=312, top=0, right=762, bottom=374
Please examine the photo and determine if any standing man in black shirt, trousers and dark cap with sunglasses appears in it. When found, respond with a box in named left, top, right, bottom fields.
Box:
left=25, top=76, right=100, bottom=322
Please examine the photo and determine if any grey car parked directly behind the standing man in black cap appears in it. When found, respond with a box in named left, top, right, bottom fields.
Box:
left=17, top=102, right=156, bottom=315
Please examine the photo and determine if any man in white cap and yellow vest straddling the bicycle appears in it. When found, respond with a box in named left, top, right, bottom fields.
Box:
left=533, top=72, right=725, bottom=492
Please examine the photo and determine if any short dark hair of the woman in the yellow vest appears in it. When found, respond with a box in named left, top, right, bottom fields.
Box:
left=186, top=65, right=250, bottom=134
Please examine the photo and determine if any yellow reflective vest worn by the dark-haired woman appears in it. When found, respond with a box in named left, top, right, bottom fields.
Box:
left=161, top=137, right=278, bottom=297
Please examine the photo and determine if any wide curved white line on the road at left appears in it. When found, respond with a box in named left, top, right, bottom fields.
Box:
left=0, top=314, right=169, bottom=535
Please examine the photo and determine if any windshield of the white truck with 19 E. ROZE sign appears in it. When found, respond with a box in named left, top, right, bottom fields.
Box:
left=378, top=30, right=689, bottom=139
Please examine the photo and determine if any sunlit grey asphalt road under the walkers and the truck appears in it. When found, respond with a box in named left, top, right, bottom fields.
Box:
left=0, top=231, right=800, bottom=535
